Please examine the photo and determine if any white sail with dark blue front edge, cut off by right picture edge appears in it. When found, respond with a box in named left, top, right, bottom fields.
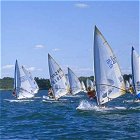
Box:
left=131, top=47, right=140, bottom=96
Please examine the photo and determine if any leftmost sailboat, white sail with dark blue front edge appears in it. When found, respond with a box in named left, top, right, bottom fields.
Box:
left=13, top=60, right=34, bottom=99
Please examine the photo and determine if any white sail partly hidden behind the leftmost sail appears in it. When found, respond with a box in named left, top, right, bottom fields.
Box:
left=22, top=66, right=39, bottom=94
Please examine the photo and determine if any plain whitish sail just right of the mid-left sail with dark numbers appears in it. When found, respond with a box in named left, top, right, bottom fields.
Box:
left=68, top=68, right=82, bottom=95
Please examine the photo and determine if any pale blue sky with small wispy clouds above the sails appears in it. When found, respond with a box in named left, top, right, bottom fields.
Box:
left=0, top=1, right=139, bottom=78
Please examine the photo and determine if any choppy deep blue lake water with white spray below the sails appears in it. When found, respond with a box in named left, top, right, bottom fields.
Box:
left=0, top=90, right=140, bottom=140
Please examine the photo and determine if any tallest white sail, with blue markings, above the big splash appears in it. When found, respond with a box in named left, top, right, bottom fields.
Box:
left=94, top=26, right=125, bottom=105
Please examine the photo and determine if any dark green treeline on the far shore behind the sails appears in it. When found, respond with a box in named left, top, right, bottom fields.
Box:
left=0, top=74, right=132, bottom=90
